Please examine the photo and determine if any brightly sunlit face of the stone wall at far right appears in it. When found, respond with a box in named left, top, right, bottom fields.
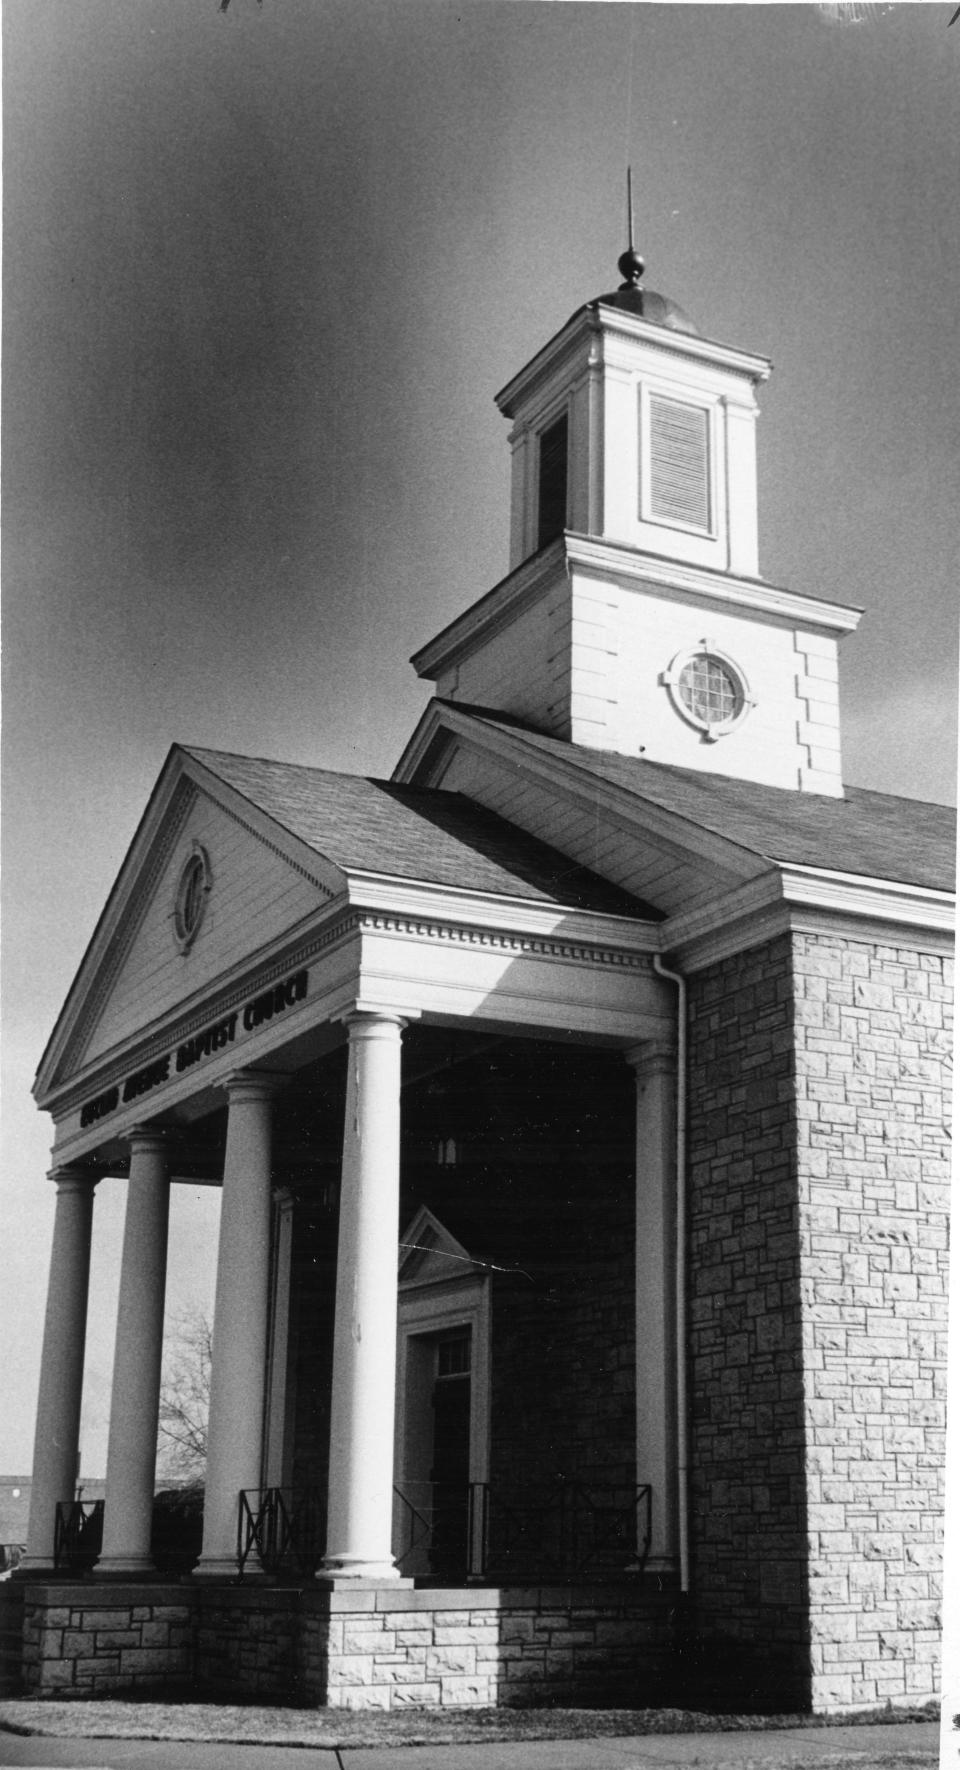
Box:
left=795, top=936, right=953, bottom=1708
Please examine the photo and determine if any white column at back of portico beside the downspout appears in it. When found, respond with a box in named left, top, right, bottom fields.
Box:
left=625, top=1043, right=678, bottom=1574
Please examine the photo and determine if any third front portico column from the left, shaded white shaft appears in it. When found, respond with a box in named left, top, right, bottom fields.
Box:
left=195, top=1071, right=276, bottom=1579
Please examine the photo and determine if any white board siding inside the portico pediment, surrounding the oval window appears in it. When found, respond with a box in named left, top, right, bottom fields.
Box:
left=83, top=797, right=326, bottom=1060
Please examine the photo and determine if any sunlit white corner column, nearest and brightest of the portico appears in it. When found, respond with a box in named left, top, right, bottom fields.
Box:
left=322, top=1012, right=404, bottom=1581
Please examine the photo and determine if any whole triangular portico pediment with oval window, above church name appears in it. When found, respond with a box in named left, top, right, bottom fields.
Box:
left=35, top=750, right=345, bottom=1101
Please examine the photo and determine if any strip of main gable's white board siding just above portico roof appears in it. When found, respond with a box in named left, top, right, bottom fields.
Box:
left=443, top=747, right=733, bottom=915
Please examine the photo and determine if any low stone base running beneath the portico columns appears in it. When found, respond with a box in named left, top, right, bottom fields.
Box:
left=15, top=1582, right=673, bottom=1708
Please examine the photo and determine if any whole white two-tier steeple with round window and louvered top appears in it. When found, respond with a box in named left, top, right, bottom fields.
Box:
left=413, top=246, right=859, bottom=795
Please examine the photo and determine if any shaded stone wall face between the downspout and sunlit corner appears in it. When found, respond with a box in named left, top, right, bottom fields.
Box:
left=687, top=936, right=809, bottom=1706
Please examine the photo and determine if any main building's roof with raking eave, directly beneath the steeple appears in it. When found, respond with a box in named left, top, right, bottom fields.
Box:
left=432, top=701, right=956, bottom=892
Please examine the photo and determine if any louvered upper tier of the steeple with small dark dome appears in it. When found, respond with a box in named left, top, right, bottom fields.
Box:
left=498, top=238, right=770, bottom=575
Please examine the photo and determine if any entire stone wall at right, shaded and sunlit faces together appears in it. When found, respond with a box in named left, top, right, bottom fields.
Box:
left=689, top=935, right=953, bottom=1712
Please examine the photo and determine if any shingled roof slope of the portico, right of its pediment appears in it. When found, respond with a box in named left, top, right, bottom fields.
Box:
left=184, top=747, right=662, bottom=922
